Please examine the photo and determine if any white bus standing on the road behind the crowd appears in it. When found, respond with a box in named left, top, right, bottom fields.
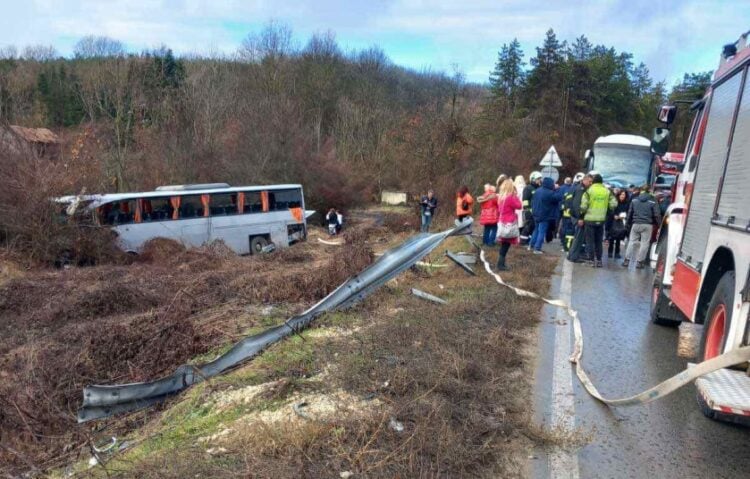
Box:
left=585, top=134, right=654, bottom=188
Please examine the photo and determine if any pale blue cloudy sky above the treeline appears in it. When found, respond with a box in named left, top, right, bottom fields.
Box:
left=0, top=0, right=750, bottom=85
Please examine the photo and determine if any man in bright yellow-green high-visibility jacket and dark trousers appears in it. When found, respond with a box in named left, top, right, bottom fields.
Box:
left=581, top=174, right=617, bottom=268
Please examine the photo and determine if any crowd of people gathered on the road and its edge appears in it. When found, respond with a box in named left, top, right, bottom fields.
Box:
left=420, top=171, right=661, bottom=271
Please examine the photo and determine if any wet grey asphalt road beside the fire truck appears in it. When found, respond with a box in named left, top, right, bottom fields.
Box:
left=530, top=253, right=750, bottom=479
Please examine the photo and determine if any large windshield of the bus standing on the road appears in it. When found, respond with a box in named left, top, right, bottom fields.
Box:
left=593, top=145, right=651, bottom=187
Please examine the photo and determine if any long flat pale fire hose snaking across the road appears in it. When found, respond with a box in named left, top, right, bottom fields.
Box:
left=479, top=250, right=750, bottom=406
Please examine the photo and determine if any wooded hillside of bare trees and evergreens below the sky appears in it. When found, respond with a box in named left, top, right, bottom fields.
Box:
left=0, top=23, right=709, bottom=213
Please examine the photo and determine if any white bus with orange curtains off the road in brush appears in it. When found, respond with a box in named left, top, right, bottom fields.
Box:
left=55, top=183, right=312, bottom=254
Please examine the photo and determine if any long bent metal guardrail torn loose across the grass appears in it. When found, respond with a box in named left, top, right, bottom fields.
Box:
left=78, top=220, right=472, bottom=422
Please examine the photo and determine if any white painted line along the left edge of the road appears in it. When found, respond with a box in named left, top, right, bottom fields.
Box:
left=549, top=259, right=580, bottom=479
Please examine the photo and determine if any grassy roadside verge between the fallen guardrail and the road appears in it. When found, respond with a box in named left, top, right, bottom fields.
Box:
left=70, top=246, right=569, bottom=478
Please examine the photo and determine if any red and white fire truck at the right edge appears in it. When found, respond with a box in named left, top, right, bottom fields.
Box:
left=651, top=28, right=750, bottom=422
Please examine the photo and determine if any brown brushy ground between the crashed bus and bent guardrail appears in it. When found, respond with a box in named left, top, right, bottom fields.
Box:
left=0, top=230, right=372, bottom=474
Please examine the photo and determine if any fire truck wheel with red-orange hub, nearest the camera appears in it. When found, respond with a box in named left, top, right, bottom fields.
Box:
left=699, top=271, right=734, bottom=361
